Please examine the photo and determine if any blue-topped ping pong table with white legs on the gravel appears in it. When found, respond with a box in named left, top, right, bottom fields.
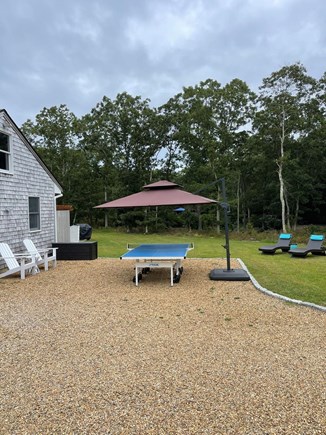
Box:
left=120, top=243, right=194, bottom=286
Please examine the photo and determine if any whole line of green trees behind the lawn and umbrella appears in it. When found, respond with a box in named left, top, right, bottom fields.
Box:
left=22, top=63, right=326, bottom=232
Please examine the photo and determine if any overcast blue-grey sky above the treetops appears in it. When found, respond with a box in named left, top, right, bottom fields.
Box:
left=0, top=0, right=326, bottom=125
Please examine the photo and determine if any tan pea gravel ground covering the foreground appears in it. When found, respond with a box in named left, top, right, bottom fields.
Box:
left=0, top=259, right=326, bottom=435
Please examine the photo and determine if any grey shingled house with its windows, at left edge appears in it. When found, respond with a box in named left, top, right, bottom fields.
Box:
left=0, top=109, right=62, bottom=268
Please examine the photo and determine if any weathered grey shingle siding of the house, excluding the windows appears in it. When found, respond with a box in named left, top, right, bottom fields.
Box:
left=0, top=112, right=61, bottom=267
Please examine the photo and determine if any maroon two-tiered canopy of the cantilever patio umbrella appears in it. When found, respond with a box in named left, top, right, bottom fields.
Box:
left=95, top=180, right=216, bottom=208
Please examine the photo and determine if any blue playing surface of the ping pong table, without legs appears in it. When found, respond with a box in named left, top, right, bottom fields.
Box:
left=120, top=243, right=192, bottom=260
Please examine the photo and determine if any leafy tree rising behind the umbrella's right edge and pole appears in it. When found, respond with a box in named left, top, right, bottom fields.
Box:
left=169, top=79, right=255, bottom=232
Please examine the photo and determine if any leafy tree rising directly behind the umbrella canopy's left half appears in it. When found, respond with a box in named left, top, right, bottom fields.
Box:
left=81, top=92, right=160, bottom=230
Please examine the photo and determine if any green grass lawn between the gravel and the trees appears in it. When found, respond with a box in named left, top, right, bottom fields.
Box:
left=92, top=229, right=326, bottom=306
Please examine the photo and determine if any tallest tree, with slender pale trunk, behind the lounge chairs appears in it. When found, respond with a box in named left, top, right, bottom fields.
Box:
left=255, top=64, right=316, bottom=232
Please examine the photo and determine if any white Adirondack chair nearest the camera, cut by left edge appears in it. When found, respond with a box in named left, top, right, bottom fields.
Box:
left=0, top=243, right=38, bottom=279
